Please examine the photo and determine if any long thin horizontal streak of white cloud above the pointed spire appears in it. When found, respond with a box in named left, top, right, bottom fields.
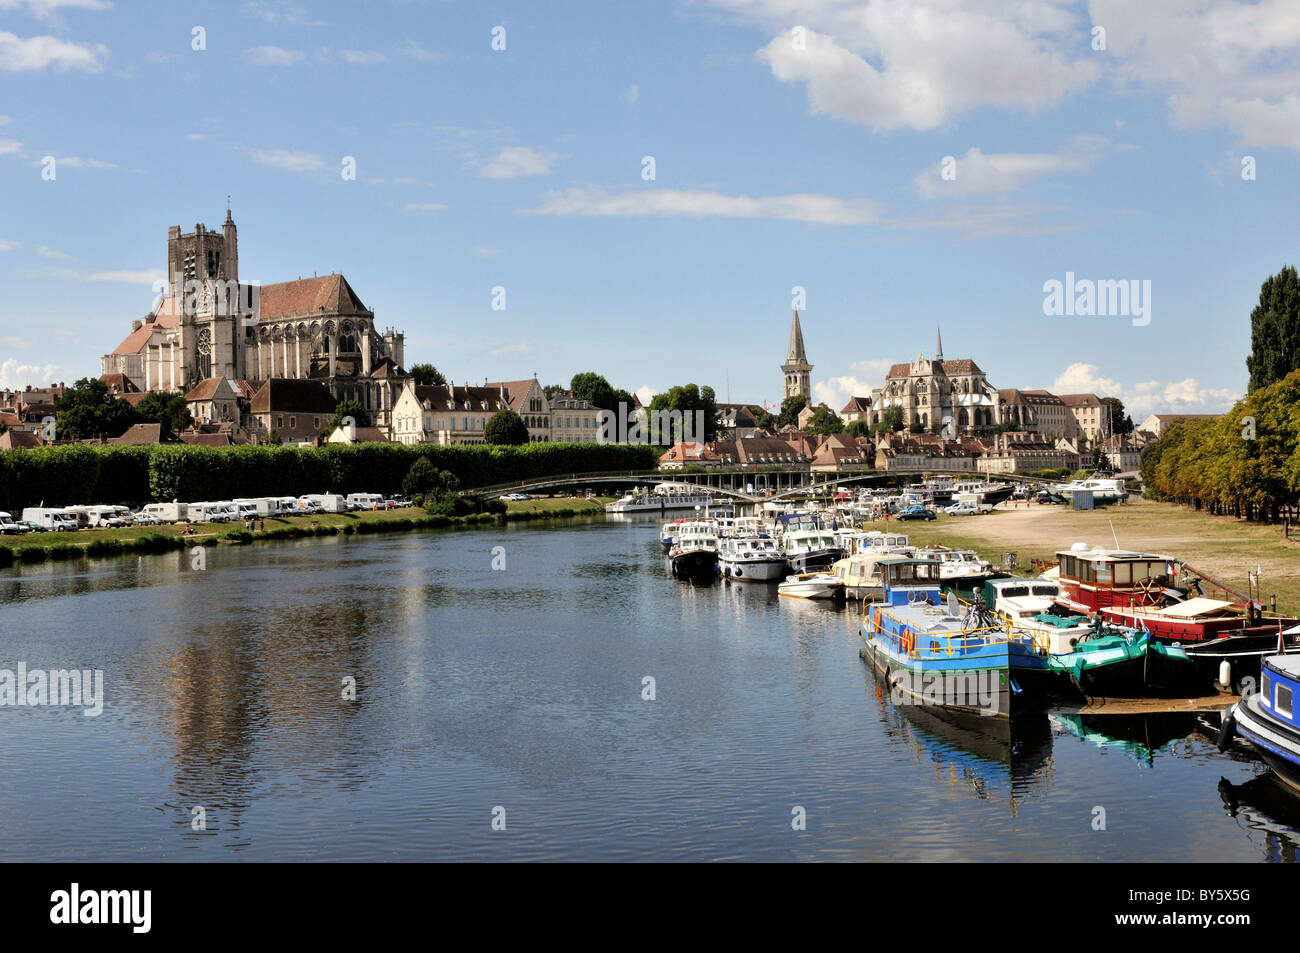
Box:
left=528, top=189, right=880, bottom=225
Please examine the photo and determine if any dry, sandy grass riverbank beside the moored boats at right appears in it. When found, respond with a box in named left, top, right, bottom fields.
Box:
left=871, top=499, right=1300, bottom=614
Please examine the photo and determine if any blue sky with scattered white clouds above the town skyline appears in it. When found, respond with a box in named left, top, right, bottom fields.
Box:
left=0, top=0, right=1300, bottom=413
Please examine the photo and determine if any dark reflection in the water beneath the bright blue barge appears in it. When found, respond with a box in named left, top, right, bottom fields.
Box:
left=867, top=671, right=1056, bottom=818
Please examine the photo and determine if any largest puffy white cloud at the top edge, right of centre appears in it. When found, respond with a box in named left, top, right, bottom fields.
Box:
left=748, top=0, right=1102, bottom=131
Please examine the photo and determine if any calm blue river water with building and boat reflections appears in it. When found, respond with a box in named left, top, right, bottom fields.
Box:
left=0, top=520, right=1300, bottom=861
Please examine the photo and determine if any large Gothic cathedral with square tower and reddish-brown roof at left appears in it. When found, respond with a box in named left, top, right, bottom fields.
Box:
left=100, top=209, right=410, bottom=426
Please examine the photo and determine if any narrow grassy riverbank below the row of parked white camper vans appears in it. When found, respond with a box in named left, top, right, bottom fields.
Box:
left=0, top=497, right=612, bottom=567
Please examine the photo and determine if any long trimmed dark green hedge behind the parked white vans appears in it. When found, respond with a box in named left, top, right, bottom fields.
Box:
left=0, top=443, right=658, bottom=519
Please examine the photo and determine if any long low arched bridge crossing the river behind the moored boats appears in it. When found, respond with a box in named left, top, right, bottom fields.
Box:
left=462, top=465, right=1056, bottom=503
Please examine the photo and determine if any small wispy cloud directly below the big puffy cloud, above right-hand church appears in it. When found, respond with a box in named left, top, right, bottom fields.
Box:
left=914, top=135, right=1113, bottom=199
